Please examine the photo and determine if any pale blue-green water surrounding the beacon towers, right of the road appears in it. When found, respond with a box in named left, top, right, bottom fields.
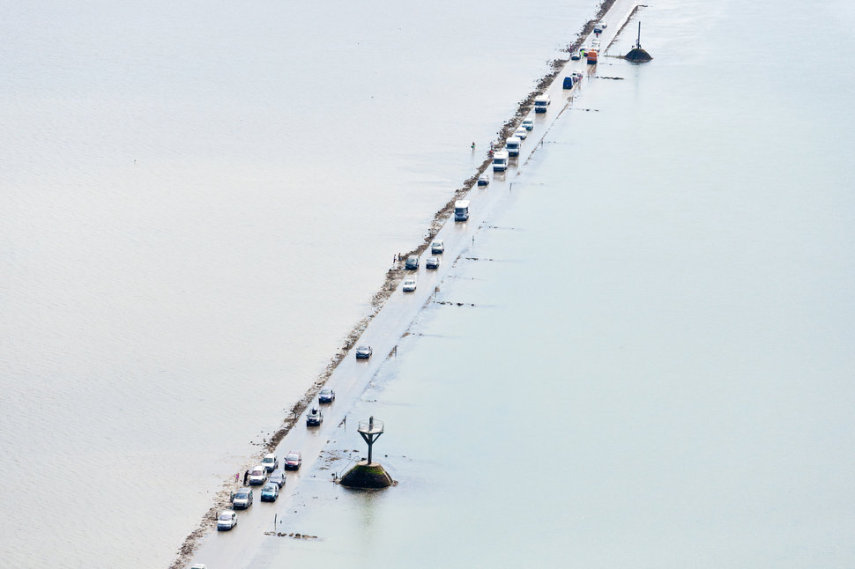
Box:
left=224, top=2, right=855, bottom=568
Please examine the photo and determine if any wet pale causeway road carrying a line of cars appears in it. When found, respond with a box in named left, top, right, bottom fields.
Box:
left=187, top=0, right=637, bottom=569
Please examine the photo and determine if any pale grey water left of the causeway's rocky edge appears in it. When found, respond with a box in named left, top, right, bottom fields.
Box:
left=0, top=1, right=594, bottom=567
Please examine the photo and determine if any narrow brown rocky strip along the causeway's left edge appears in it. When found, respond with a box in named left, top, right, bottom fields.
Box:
left=169, top=0, right=620, bottom=569
